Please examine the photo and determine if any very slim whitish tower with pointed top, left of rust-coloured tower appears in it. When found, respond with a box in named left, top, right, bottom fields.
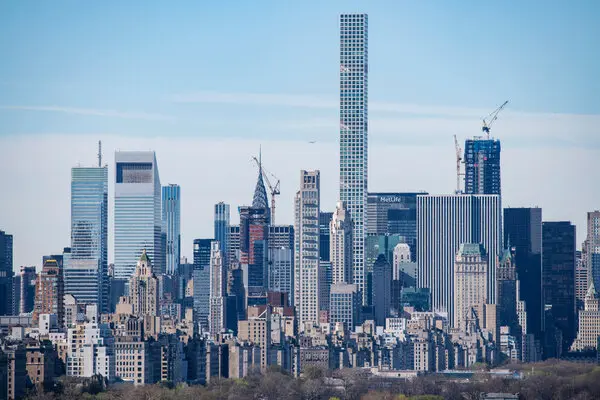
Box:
left=209, top=240, right=227, bottom=336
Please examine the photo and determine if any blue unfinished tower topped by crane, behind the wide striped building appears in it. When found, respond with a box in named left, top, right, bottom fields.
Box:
left=464, top=137, right=502, bottom=194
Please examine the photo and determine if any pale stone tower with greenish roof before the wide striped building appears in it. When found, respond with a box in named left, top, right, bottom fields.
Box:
left=452, top=243, right=488, bottom=331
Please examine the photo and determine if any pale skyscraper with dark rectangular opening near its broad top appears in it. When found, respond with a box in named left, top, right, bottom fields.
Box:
left=114, top=151, right=164, bottom=280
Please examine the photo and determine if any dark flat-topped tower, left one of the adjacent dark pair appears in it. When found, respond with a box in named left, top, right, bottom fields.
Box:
left=504, top=208, right=543, bottom=340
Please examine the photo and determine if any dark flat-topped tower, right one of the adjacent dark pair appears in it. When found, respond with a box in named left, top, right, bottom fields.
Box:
left=542, top=221, right=576, bottom=351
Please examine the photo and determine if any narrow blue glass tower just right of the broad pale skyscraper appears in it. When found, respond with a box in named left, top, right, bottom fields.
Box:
left=162, top=183, right=181, bottom=275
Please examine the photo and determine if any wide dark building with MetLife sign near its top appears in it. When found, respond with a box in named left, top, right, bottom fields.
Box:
left=367, top=192, right=428, bottom=260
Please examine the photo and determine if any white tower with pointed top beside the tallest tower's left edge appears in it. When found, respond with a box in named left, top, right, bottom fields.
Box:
left=329, top=201, right=352, bottom=284
